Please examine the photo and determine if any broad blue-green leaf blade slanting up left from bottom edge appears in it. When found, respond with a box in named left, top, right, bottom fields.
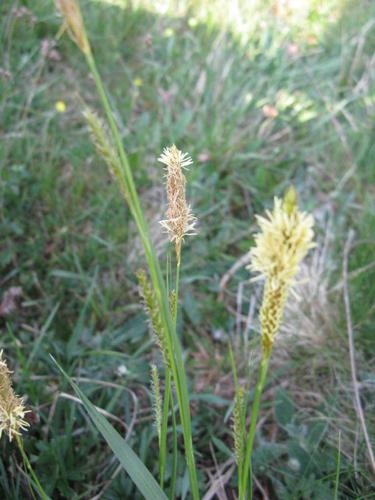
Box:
left=51, top=356, right=167, bottom=500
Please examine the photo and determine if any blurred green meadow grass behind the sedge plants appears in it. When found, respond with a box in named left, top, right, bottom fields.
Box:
left=0, top=0, right=375, bottom=500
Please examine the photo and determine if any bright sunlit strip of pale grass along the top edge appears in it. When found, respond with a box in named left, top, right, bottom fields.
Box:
left=96, top=0, right=343, bottom=45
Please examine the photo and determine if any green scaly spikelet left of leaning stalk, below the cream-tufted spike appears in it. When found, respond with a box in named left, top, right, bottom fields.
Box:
left=137, top=269, right=170, bottom=366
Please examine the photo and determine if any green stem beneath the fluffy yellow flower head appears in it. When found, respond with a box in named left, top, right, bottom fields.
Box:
left=239, top=355, right=270, bottom=500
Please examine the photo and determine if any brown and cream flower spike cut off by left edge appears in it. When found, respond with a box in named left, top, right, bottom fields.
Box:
left=0, top=351, right=29, bottom=441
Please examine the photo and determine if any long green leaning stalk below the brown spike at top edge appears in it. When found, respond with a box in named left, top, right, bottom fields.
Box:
left=85, top=47, right=199, bottom=500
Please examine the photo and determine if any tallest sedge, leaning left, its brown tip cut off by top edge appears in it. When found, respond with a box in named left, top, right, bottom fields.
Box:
left=57, top=0, right=199, bottom=500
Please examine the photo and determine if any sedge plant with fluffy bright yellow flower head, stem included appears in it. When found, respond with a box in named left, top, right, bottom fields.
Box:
left=238, top=188, right=314, bottom=500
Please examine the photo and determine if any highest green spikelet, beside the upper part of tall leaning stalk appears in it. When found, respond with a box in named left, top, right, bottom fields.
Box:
left=83, top=108, right=129, bottom=201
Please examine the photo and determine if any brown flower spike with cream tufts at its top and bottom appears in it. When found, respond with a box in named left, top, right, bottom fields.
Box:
left=159, top=144, right=196, bottom=262
